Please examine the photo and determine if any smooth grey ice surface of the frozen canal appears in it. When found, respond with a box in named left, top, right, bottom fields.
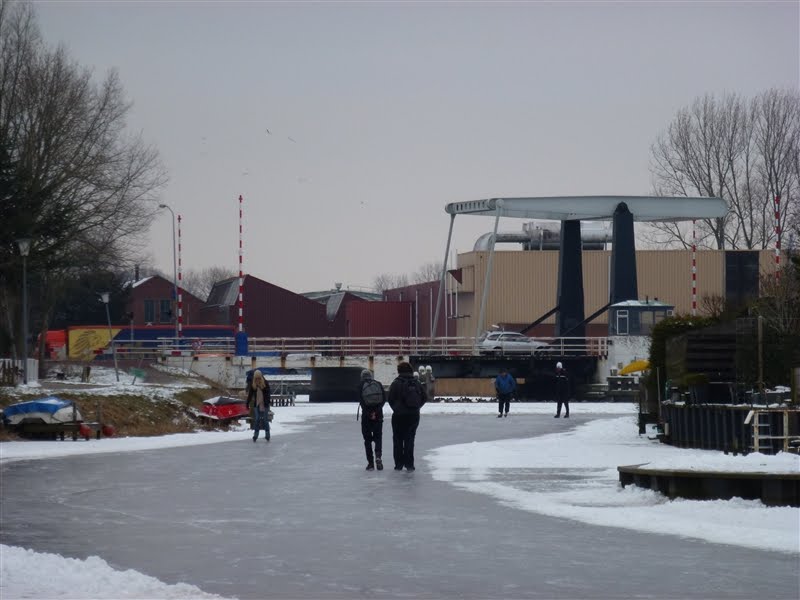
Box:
left=0, top=415, right=798, bottom=599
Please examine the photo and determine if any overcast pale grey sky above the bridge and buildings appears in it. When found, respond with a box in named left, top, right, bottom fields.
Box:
left=37, top=0, right=800, bottom=292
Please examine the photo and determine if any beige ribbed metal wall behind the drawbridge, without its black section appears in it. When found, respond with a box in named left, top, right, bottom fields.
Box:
left=457, top=250, right=775, bottom=336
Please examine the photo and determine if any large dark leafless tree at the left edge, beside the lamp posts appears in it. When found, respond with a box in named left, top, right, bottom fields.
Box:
left=0, top=2, right=166, bottom=356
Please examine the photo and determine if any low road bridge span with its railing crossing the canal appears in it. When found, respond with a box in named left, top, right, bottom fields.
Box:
left=101, top=337, right=610, bottom=397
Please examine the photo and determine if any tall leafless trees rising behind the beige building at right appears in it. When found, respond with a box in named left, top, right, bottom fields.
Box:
left=650, top=89, right=800, bottom=248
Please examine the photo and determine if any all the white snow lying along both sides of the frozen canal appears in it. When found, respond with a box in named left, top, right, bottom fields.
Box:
left=0, top=369, right=800, bottom=600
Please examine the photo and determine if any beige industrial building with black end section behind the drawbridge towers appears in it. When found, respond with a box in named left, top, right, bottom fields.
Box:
left=444, top=244, right=775, bottom=337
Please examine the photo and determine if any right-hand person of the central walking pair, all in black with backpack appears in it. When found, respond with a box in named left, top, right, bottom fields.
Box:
left=389, top=362, right=427, bottom=471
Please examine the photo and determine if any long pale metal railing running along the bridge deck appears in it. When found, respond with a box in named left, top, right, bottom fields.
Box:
left=100, top=337, right=608, bottom=360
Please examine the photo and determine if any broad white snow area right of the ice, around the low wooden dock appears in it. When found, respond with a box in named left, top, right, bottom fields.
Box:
left=425, top=418, right=800, bottom=554
